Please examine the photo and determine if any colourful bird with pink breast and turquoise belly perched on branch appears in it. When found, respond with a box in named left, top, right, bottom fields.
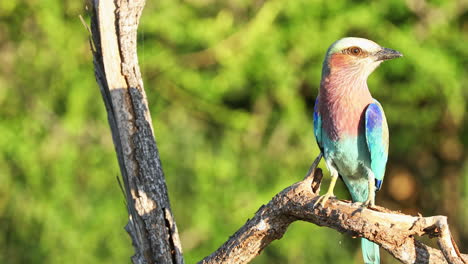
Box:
left=313, top=37, right=403, bottom=264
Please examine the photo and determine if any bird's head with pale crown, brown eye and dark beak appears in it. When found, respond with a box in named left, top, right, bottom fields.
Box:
left=322, top=38, right=403, bottom=79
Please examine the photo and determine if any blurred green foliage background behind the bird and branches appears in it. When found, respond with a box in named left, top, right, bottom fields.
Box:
left=0, top=0, right=468, bottom=264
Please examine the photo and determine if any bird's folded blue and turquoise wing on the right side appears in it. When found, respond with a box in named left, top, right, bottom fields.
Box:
left=365, top=100, right=388, bottom=190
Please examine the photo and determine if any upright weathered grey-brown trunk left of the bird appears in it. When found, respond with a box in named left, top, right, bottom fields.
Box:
left=91, top=0, right=184, bottom=263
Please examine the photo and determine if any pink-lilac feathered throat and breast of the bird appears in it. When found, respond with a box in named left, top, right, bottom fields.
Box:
left=318, top=54, right=373, bottom=141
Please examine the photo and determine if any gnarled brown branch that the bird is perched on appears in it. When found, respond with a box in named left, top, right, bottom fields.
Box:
left=199, top=156, right=468, bottom=264
